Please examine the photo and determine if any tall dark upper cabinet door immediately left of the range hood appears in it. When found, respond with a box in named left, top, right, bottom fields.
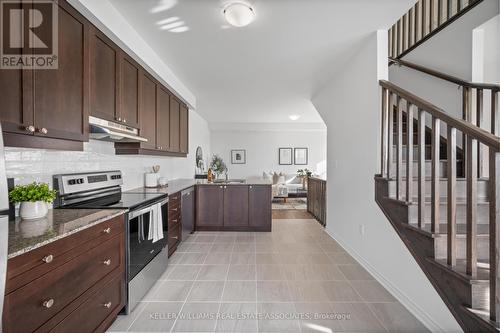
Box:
left=33, top=2, right=88, bottom=141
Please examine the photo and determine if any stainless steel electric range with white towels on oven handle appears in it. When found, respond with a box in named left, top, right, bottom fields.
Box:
left=53, top=171, right=168, bottom=314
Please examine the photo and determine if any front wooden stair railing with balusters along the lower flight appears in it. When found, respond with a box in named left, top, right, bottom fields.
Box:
left=380, top=80, right=500, bottom=330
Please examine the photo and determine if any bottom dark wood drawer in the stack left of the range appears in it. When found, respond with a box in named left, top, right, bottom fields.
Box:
left=51, top=275, right=125, bottom=333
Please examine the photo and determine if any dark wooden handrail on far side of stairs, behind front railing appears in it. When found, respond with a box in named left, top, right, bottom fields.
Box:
left=389, top=57, right=500, bottom=177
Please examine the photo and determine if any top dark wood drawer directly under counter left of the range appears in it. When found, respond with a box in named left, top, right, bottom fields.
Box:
left=6, top=215, right=125, bottom=293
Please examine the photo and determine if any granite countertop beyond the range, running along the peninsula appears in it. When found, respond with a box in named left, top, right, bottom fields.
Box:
left=126, top=178, right=272, bottom=195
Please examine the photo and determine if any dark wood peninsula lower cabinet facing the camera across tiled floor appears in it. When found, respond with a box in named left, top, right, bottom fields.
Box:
left=195, top=184, right=272, bottom=231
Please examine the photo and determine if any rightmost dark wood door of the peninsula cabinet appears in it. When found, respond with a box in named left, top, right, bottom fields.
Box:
left=248, top=185, right=272, bottom=231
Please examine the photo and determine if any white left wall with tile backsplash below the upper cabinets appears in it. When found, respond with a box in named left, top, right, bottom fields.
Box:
left=5, top=111, right=210, bottom=190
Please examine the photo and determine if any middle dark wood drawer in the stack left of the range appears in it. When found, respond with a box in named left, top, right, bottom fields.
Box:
left=3, top=234, right=125, bottom=332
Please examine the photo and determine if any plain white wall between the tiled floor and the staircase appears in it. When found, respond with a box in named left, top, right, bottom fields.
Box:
left=312, top=31, right=461, bottom=332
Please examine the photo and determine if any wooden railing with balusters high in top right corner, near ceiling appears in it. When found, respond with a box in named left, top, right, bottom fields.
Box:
left=389, top=0, right=483, bottom=58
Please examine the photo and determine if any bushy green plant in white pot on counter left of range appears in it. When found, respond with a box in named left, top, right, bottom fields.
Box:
left=9, top=182, right=56, bottom=220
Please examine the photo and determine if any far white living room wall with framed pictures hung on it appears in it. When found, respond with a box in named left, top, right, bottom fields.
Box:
left=211, top=125, right=326, bottom=178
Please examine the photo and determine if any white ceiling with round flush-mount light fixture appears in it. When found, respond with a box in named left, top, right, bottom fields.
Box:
left=109, top=0, right=415, bottom=123
